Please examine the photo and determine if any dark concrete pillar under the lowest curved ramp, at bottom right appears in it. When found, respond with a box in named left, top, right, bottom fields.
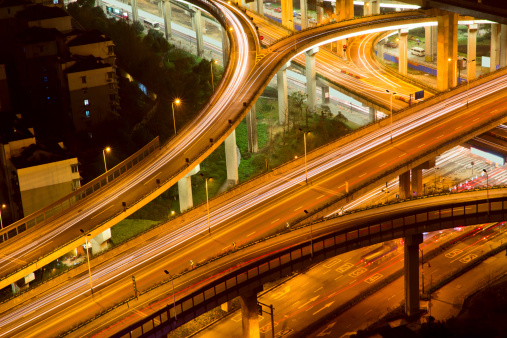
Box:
left=404, top=234, right=422, bottom=316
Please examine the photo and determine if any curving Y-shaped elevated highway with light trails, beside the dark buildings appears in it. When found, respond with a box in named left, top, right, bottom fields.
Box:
left=0, top=9, right=440, bottom=287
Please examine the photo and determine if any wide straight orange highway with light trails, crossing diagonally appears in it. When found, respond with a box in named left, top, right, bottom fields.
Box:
left=0, top=4, right=506, bottom=336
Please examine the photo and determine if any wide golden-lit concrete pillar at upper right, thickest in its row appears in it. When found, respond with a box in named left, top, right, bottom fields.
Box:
left=437, top=12, right=458, bottom=91
